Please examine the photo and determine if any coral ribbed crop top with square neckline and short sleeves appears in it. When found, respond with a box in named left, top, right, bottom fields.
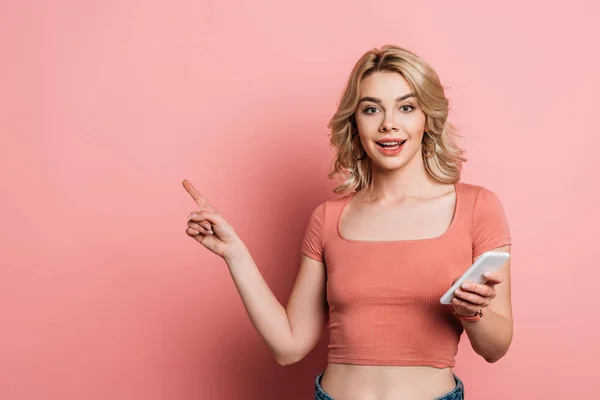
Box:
left=302, top=183, right=510, bottom=368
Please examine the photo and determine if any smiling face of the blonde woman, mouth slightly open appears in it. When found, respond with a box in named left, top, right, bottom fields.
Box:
left=355, top=71, right=426, bottom=170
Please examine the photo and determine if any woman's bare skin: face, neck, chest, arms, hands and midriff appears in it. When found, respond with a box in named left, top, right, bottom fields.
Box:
left=183, top=72, right=512, bottom=400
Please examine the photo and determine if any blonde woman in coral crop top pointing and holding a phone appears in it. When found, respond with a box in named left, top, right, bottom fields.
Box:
left=184, top=46, right=512, bottom=400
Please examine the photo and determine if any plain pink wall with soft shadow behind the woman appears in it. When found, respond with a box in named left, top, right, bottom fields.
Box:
left=0, top=0, right=600, bottom=400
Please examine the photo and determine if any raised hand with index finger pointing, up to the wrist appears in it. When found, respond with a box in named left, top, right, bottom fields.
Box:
left=182, top=179, right=243, bottom=259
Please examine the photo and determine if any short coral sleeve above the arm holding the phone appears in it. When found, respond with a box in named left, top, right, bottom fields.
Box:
left=472, top=187, right=511, bottom=258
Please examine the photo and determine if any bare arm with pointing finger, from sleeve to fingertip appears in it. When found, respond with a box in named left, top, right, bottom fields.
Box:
left=183, top=181, right=327, bottom=365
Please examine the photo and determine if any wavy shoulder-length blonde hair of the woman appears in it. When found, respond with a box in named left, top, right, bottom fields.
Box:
left=328, top=45, right=466, bottom=193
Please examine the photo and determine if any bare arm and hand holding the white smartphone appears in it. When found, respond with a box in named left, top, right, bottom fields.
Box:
left=452, top=245, right=513, bottom=363
